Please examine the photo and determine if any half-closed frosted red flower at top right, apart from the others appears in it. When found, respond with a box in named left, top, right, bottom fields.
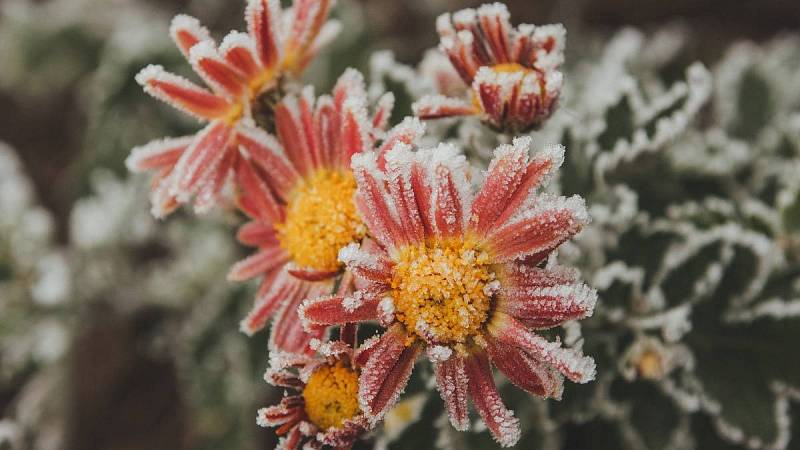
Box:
left=414, top=3, right=566, bottom=133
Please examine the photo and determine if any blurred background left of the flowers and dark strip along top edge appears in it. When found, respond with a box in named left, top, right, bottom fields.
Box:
left=0, top=0, right=800, bottom=450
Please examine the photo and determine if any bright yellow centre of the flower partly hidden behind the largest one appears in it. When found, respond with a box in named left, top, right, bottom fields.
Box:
left=275, top=169, right=366, bottom=271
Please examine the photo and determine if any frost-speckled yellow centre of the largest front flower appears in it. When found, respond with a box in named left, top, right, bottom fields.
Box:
left=392, top=239, right=497, bottom=344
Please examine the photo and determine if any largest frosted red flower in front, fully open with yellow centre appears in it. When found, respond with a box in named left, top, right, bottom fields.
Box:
left=300, top=138, right=597, bottom=446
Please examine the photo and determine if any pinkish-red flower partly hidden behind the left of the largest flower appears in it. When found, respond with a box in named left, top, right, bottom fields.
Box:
left=228, top=69, right=422, bottom=352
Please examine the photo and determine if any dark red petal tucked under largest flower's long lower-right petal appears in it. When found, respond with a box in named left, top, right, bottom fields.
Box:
left=486, top=336, right=564, bottom=400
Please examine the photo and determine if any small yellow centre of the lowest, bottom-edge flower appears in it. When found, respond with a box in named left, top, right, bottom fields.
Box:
left=303, top=362, right=361, bottom=430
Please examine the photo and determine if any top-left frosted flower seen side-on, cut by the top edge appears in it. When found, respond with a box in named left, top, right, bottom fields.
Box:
left=127, top=0, right=339, bottom=217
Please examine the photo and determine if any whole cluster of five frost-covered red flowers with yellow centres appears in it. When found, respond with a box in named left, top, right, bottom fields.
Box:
left=128, top=0, right=596, bottom=449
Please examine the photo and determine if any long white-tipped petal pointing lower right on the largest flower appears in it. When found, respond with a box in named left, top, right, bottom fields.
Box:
left=488, top=312, right=595, bottom=383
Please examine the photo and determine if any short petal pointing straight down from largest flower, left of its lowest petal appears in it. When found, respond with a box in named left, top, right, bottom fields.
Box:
left=435, top=355, right=469, bottom=431
